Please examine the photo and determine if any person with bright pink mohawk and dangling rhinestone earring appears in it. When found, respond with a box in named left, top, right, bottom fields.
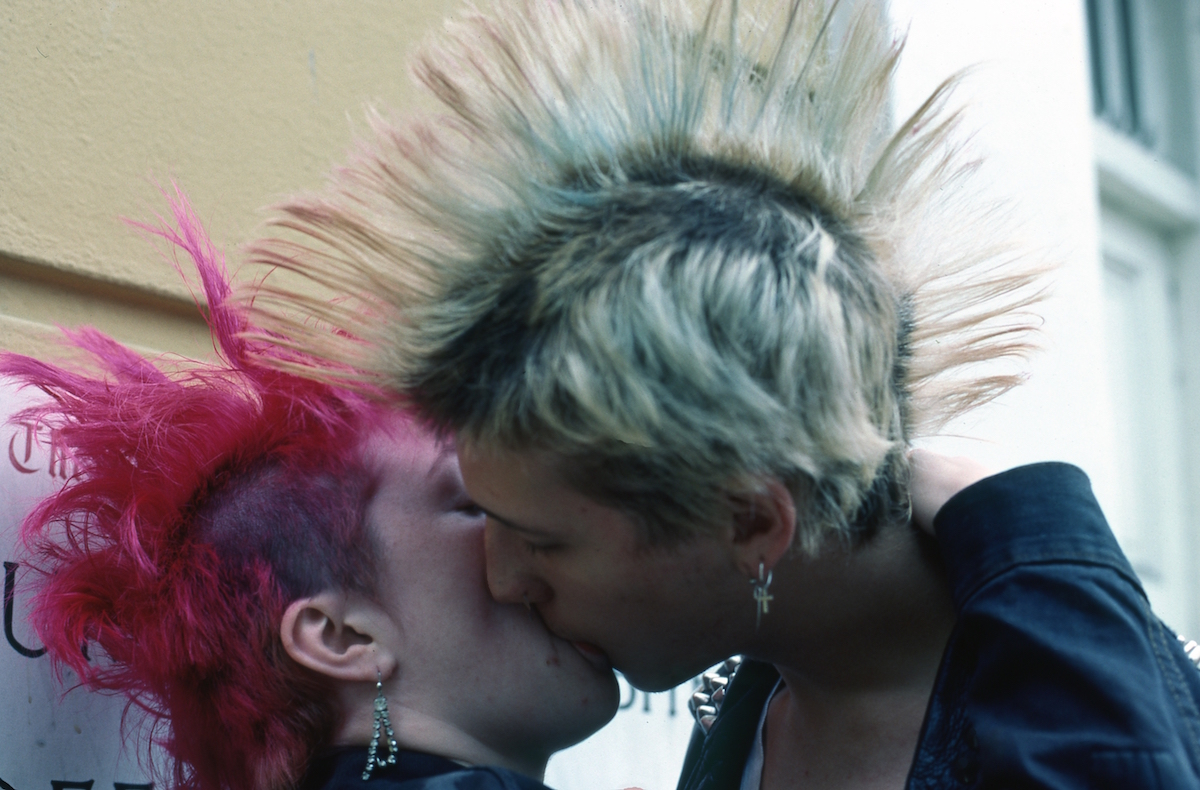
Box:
left=0, top=192, right=618, bottom=790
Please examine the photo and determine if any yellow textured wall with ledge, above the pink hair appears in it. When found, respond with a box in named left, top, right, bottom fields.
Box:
left=0, top=0, right=454, bottom=355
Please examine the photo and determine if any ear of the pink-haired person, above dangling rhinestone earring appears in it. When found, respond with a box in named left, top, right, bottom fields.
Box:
left=280, top=591, right=400, bottom=681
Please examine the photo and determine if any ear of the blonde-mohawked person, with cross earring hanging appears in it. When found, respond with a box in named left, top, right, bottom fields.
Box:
left=732, top=478, right=796, bottom=579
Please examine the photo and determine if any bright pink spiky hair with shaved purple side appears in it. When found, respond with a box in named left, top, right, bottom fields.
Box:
left=0, top=188, right=379, bottom=790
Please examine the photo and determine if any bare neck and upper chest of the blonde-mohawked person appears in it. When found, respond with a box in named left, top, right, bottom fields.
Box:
left=748, top=527, right=954, bottom=790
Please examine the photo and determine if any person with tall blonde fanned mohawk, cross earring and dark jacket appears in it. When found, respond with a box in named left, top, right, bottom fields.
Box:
left=243, top=0, right=1200, bottom=790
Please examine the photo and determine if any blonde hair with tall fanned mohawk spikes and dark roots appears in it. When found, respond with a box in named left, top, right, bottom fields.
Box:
left=254, top=0, right=1037, bottom=551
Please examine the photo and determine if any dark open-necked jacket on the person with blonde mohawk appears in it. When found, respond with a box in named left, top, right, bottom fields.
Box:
left=679, top=463, right=1200, bottom=790
